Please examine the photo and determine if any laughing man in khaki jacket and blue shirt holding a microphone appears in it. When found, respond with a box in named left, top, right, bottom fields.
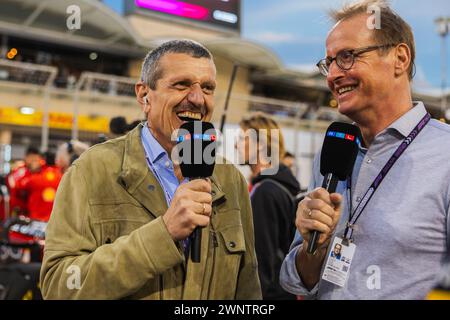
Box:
left=41, top=40, right=261, bottom=299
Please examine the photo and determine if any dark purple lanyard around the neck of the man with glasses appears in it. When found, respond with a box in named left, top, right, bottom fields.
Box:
left=344, top=113, right=431, bottom=241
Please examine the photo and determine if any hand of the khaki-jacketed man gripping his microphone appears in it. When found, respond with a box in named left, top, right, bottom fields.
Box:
left=162, top=179, right=212, bottom=241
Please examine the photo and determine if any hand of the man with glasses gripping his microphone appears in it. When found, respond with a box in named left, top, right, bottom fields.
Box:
left=295, top=188, right=342, bottom=252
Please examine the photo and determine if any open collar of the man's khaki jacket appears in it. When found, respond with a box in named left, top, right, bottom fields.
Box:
left=119, top=123, right=225, bottom=218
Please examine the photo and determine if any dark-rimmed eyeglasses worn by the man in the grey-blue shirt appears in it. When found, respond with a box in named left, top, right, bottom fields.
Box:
left=316, top=44, right=396, bottom=77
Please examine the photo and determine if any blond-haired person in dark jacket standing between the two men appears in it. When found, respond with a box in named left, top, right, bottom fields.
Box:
left=238, top=114, right=300, bottom=300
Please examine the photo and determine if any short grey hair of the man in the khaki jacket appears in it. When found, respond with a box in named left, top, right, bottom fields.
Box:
left=141, top=40, right=213, bottom=90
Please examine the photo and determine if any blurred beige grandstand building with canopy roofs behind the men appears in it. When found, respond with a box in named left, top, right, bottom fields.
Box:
left=0, top=0, right=443, bottom=184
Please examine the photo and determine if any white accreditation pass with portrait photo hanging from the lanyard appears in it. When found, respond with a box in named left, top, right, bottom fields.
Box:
left=322, top=237, right=356, bottom=287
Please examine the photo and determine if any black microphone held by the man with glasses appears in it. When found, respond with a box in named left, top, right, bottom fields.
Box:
left=307, top=122, right=361, bottom=254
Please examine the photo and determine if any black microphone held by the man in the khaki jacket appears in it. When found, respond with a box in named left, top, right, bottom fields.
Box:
left=177, top=121, right=217, bottom=263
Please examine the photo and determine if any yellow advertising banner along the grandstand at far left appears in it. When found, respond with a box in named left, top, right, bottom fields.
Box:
left=0, top=108, right=109, bottom=133
